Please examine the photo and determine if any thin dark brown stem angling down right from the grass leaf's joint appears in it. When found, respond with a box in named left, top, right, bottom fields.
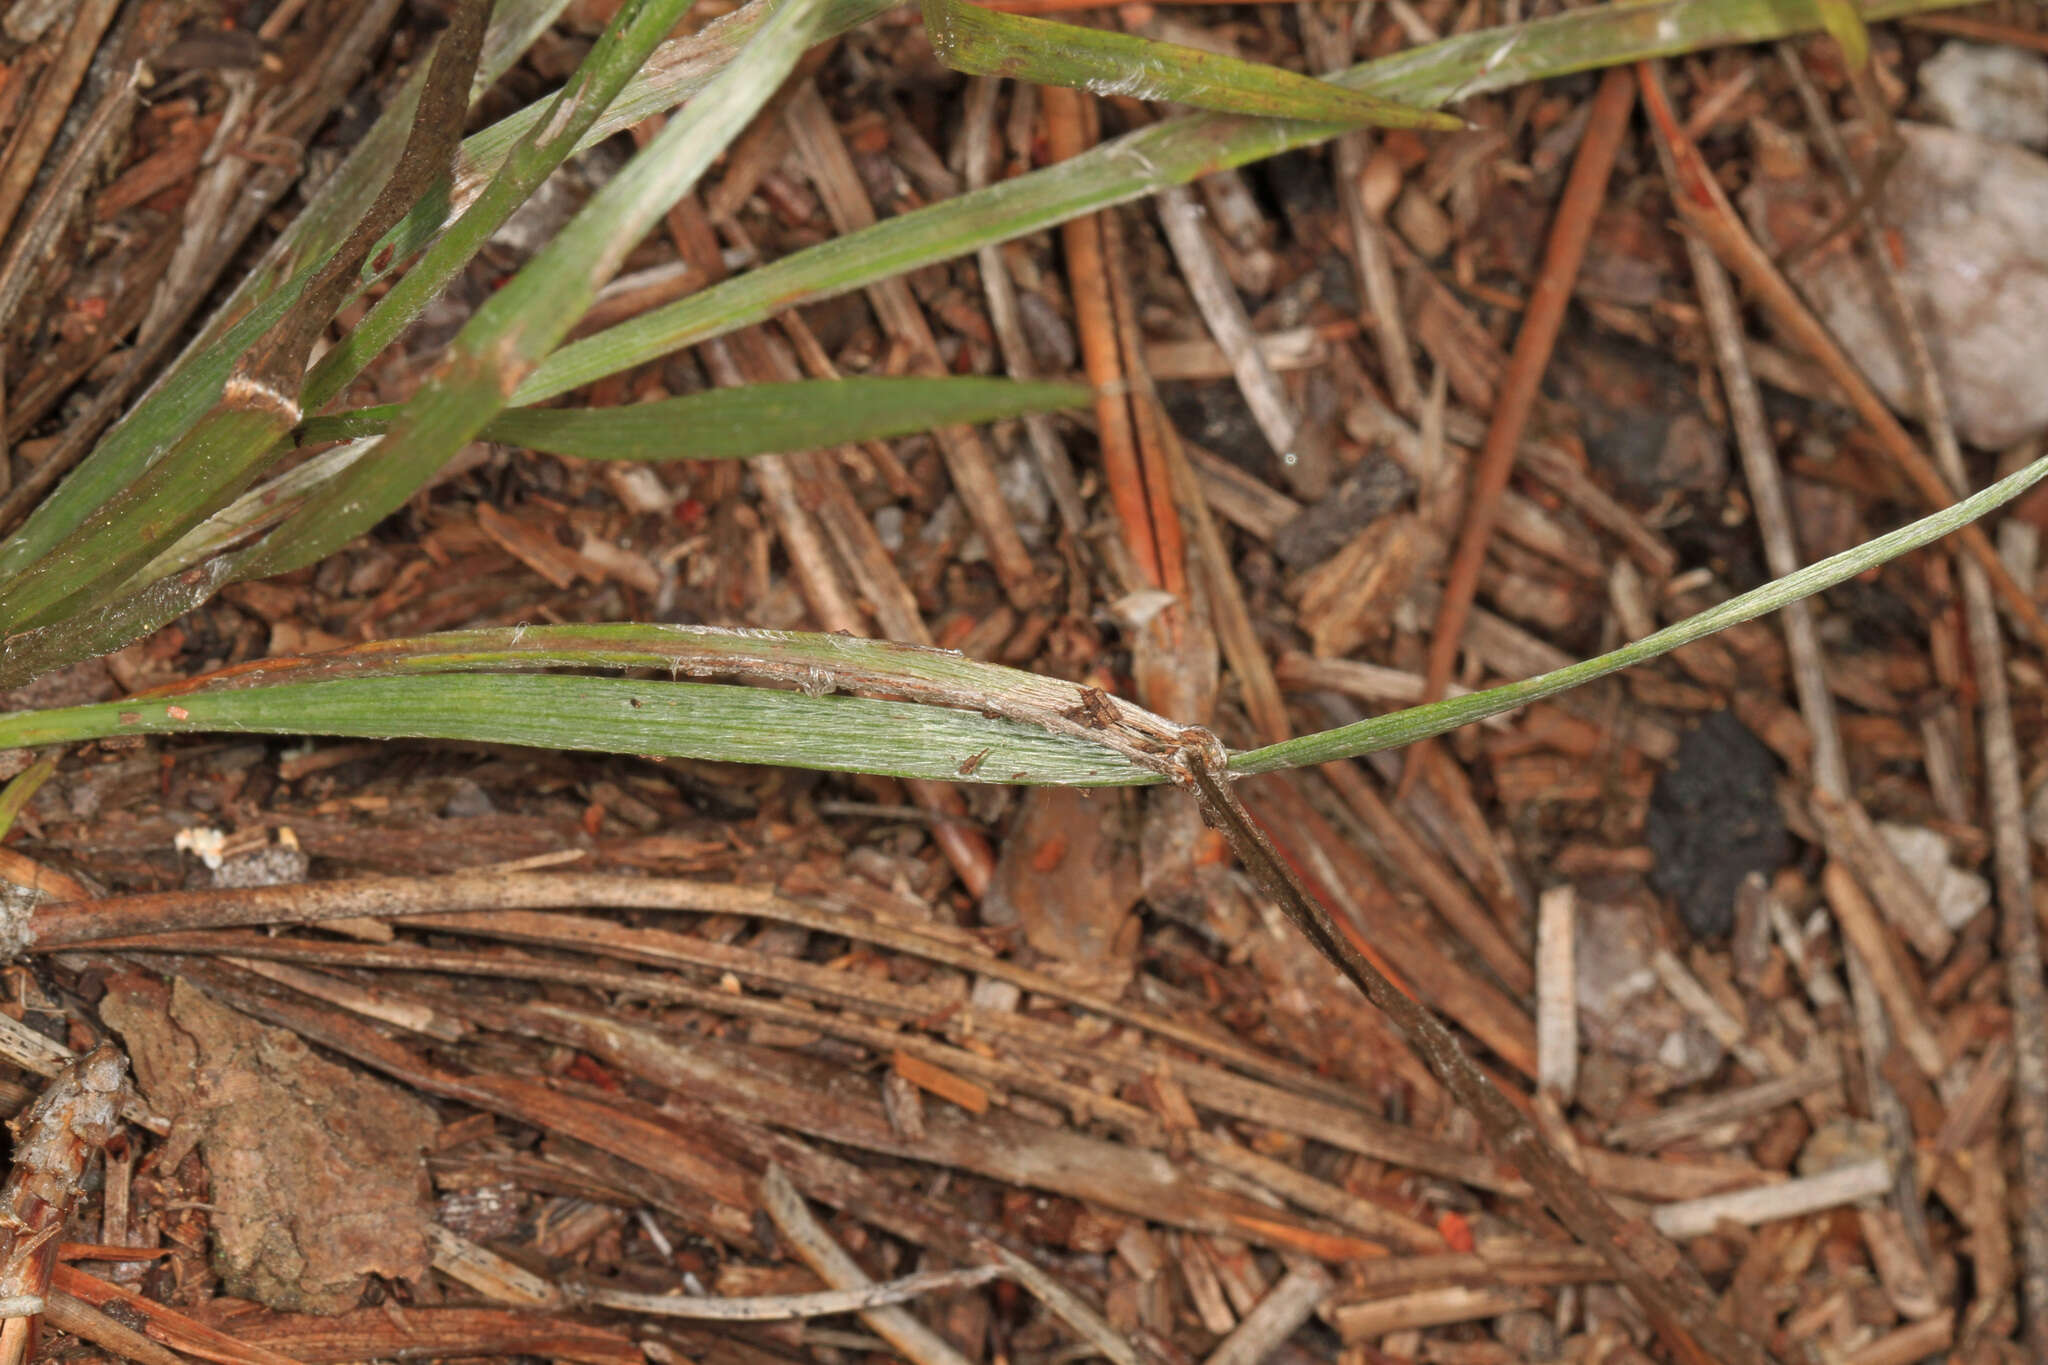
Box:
left=1182, top=745, right=1772, bottom=1365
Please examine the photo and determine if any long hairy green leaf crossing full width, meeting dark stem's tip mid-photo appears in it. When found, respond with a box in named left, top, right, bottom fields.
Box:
left=0, top=446, right=2048, bottom=786
